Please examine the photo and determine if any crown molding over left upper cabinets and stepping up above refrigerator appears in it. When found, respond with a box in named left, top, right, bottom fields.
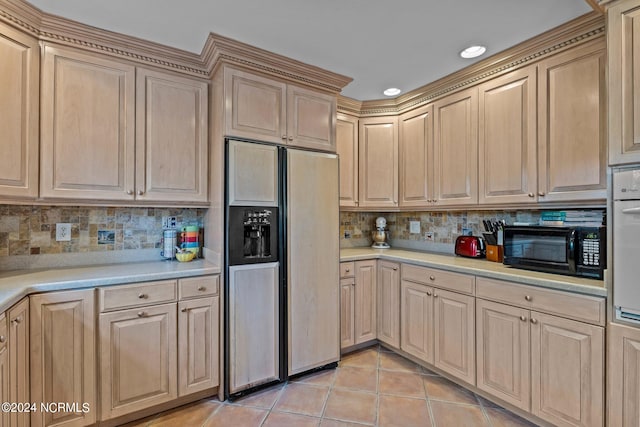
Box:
left=0, top=0, right=353, bottom=93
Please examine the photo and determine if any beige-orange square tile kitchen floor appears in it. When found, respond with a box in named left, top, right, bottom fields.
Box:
left=122, top=346, right=534, bottom=427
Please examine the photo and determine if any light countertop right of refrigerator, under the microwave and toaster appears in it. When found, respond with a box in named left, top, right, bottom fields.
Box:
left=340, top=248, right=607, bottom=296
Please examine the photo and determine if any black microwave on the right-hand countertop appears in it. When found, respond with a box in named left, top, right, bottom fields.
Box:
left=504, top=226, right=607, bottom=279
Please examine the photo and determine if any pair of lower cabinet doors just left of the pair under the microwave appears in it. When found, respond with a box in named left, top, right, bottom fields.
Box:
left=400, top=280, right=476, bottom=385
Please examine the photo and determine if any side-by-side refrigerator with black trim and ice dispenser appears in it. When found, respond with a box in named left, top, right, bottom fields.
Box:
left=225, top=140, right=340, bottom=398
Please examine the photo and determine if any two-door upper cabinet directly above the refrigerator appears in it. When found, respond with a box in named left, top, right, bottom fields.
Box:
left=224, top=68, right=336, bottom=152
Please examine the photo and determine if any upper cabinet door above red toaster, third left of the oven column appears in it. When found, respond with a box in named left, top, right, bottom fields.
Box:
left=433, top=87, right=478, bottom=206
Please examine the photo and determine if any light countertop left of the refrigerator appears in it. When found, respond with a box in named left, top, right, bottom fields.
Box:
left=0, top=260, right=220, bottom=312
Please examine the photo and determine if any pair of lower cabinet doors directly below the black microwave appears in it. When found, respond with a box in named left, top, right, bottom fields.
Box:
left=477, top=299, right=604, bottom=427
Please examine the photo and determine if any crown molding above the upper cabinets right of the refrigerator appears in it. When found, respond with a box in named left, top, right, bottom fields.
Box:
left=338, top=12, right=605, bottom=117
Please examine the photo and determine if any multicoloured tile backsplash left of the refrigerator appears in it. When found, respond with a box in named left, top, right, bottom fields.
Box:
left=0, top=205, right=205, bottom=257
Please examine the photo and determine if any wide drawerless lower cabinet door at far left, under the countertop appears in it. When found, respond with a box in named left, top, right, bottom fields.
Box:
left=30, top=289, right=95, bottom=426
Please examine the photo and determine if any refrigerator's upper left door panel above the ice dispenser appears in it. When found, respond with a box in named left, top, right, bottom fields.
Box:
left=227, top=141, right=278, bottom=206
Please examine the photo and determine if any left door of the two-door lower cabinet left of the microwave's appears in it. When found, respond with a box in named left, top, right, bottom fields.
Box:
left=400, top=280, right=433, bottom=363
